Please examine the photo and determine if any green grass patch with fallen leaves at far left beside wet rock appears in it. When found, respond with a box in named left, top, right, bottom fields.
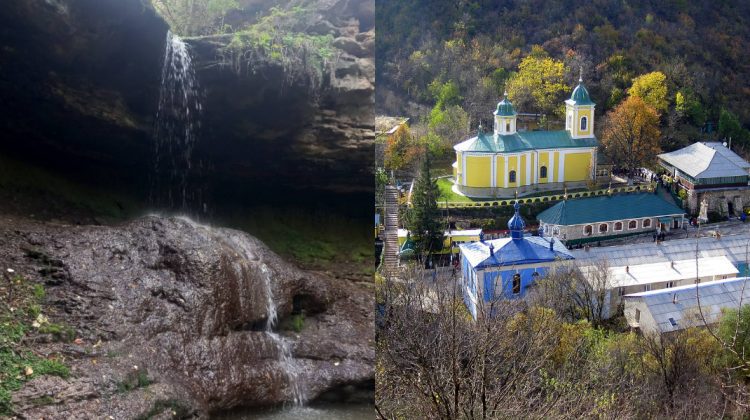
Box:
left=0, top=276, right=70, bottom=416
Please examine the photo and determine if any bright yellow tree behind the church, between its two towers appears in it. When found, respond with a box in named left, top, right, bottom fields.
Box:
left=506, top=45, right=570, bottom=116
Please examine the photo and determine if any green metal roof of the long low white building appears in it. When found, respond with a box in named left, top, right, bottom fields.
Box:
left=537, top=193, right=685, bottom=225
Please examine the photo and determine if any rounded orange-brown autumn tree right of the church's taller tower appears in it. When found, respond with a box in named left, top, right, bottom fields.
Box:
left=602, top=96, right=661, bottom=170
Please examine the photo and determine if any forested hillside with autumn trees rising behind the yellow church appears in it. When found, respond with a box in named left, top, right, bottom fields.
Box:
left=376, top=0, right=750, bottom=159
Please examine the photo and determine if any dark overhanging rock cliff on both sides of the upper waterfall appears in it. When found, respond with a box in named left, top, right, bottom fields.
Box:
left=0, top=0, right=374, bottom=202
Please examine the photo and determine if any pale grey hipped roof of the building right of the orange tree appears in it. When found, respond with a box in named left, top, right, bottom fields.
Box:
left=659, top=142, right=750, bottom=179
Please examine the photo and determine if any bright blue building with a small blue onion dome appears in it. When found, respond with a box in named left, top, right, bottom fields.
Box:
left=459, top=203, right=573, bottom=319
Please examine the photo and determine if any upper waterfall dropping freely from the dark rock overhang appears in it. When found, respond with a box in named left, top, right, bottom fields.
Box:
left=151, top=32, right=205, bottom=213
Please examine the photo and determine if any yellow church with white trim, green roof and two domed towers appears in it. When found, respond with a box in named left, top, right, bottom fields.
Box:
left=453, top=79, right=599, bottom=197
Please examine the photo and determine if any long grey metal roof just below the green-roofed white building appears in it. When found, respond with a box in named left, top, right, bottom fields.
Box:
left=570, top=225, right=750, bottom=267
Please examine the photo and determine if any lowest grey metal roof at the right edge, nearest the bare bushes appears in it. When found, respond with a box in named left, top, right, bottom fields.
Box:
left=623, top=277, right=750, bottom=333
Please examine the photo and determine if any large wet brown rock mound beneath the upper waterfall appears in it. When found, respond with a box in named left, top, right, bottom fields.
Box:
left=0, top=216, right=375, bottom=418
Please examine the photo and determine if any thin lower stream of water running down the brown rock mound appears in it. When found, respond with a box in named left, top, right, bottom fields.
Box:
left=228, top=234, right=307, bottom=405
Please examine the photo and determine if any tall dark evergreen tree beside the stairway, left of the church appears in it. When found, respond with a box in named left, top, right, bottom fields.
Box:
left=406, top=152, right=443, bottom=255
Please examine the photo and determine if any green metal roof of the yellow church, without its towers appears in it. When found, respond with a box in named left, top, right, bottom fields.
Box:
left=454, top=130, right=599, bottom=153
